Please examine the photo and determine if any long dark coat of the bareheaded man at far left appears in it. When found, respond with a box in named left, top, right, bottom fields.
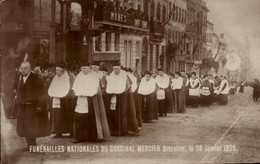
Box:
left=15, top=73, right=50, bottom=138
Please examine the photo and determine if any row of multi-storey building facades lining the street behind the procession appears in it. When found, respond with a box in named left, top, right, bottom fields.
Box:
left=1, top=0, right=221, bottom=74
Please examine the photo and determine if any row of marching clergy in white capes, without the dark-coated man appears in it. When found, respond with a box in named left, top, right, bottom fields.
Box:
left=48, top=63, right=229, bottom=143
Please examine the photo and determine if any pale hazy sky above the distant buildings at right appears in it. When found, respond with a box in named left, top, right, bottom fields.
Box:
left=205, top=0, right=260, bottom=71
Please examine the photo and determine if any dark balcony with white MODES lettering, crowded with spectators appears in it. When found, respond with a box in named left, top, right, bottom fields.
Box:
left=95, top=1, right=149, bottom=31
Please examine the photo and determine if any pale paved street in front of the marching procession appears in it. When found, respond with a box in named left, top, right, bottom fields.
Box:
left=1, top=88, right=260, bottom=164
